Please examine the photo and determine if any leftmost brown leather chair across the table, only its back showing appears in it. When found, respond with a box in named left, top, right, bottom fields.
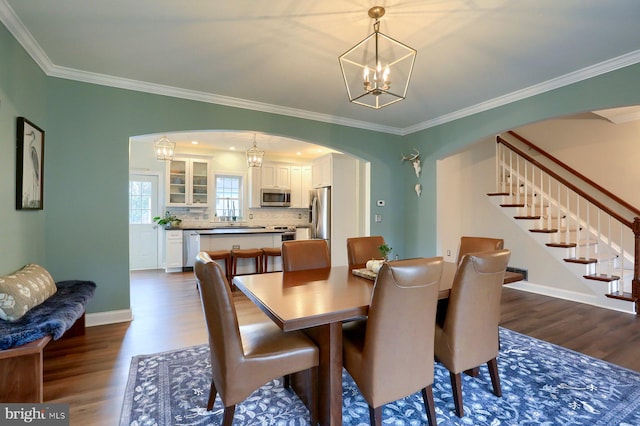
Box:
left=282, top=240, right=331, bottom=272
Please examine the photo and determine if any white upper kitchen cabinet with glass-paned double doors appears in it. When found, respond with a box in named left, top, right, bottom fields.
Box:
left=167, top=158, right=210, bottom=207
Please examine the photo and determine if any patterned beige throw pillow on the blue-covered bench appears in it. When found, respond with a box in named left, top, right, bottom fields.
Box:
left=0, top=264, right=58, bottom=321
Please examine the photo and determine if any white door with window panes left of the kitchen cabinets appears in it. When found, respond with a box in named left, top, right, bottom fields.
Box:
left=129, top=174, right=161, bottom=270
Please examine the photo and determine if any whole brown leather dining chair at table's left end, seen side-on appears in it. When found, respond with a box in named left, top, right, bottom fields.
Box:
left=195, top=252, right=319, bottom=425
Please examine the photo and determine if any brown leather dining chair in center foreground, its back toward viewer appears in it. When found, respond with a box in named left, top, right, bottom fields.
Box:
left=343, top=257, right=443, bottom=425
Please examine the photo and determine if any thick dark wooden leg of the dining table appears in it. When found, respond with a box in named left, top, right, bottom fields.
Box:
left=305, top=322, right=342, bottom=426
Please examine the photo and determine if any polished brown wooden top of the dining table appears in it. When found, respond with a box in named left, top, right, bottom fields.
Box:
left=233, top=262, right=456, bottom=331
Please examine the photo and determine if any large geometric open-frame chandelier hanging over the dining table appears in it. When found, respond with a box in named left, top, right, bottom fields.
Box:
left=338, top=6, right=417, bottom=109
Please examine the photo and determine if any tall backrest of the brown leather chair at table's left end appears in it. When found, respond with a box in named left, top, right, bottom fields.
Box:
left=194, top=252, right=244, bottom=400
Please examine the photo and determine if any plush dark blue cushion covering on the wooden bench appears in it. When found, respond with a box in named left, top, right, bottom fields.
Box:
left=0, top=281, right=96, bottom=350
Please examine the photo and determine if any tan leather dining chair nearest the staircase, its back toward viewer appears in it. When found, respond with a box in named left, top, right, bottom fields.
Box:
left=435, top=250, right=511, bottom=417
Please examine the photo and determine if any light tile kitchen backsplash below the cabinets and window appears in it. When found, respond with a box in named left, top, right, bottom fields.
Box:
left=167, top=207, right=309, bottom=228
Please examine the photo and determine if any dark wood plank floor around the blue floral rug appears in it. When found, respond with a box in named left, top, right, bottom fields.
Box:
left=44, top=271, right=640, bottom=426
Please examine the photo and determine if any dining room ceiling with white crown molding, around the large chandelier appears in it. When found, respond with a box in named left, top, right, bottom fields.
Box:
left=0, top=0, right=640, bottom=155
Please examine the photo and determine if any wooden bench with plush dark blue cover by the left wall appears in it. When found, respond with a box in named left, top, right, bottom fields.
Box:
left=0, top=280, right=96, bottom=403
